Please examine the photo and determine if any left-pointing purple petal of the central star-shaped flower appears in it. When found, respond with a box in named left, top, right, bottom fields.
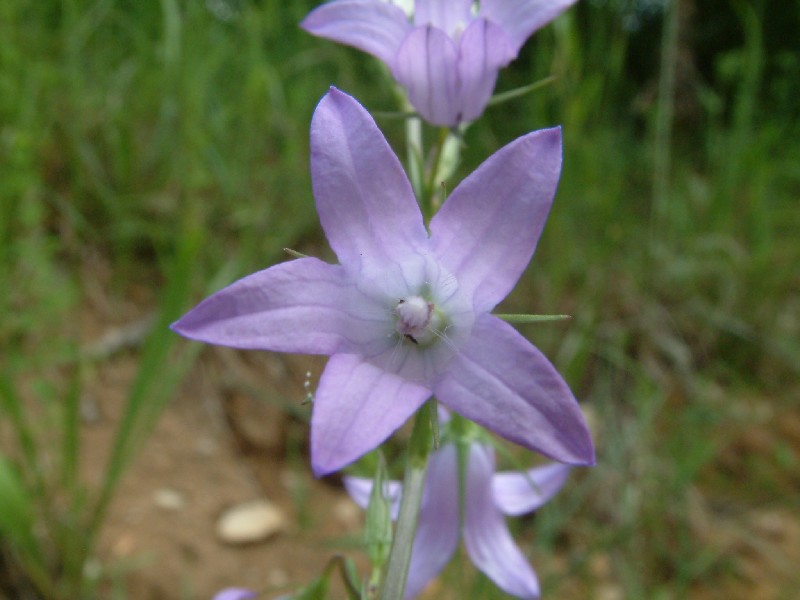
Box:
left=172, top=258, right=363, bottom=354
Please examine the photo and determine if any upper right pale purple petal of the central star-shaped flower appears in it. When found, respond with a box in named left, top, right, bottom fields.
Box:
left=430, top=128, right=561, bottom=313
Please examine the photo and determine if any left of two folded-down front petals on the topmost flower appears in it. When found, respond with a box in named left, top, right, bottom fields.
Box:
left=393, top=26, right=460, bottom=126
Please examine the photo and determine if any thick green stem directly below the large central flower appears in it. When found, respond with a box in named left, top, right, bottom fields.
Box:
left=382, top=402, right=436, bottom=600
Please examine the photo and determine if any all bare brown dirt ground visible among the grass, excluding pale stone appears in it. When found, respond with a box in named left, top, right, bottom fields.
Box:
left=53, top=258, right=800, bottom=600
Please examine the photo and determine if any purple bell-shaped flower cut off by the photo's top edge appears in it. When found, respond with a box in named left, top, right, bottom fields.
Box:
left=300, top=0, right=575, bottom=126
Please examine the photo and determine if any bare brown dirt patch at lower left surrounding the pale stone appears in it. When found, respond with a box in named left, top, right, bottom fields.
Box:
left=70, top=257, right=362, bottom=600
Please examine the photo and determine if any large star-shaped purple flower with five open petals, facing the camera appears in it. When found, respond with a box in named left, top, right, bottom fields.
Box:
left=173, top=89, right=594, bottom=475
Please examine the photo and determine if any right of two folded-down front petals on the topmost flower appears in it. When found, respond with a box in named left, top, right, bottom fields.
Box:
left=458, top=19, right=516, bottom=121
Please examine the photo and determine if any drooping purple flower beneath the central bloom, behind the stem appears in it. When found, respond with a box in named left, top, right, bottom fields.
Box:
left=344, top=443, right=570, bottom=598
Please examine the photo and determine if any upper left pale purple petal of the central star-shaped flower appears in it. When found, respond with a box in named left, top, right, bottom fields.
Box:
left=311, top=88, right=428, bottom=273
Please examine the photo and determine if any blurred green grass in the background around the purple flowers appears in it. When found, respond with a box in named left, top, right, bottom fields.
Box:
left=0, top=0, right=800, bottom=598
